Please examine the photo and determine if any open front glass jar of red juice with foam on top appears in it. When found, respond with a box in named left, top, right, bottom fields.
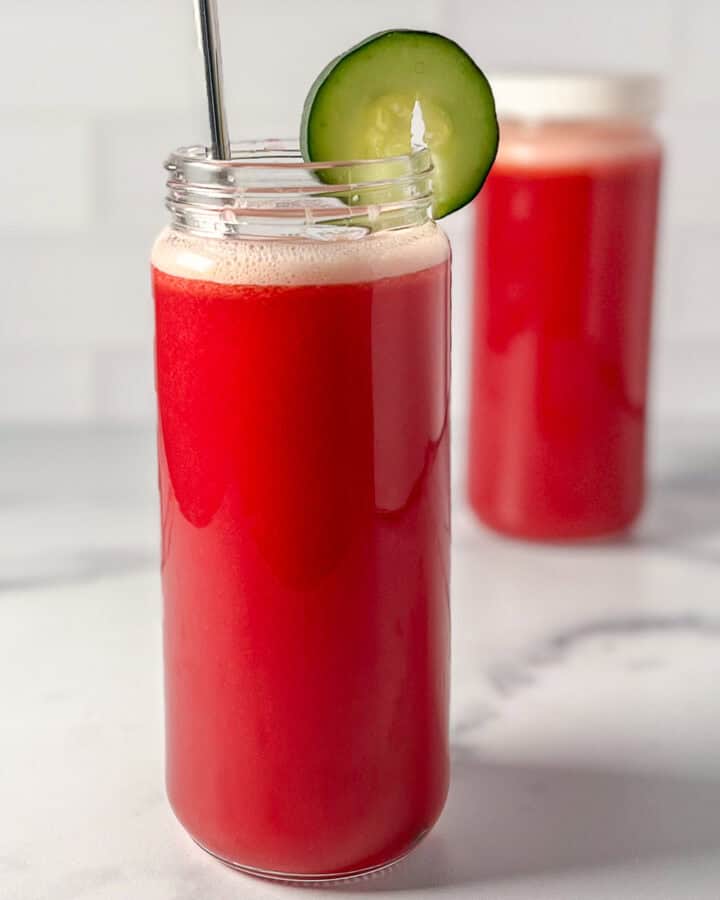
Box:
left=152, top=142, right=450, bottom=881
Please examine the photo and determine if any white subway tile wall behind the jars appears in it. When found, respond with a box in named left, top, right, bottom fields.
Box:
left=0, top=0, right=720, bottom=436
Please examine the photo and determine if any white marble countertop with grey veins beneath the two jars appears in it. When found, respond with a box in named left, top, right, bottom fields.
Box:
left=0, top=421, right=720, bottom=900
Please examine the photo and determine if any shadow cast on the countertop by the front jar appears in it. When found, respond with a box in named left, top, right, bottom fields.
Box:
left=335, top=747, right=720, bottom=893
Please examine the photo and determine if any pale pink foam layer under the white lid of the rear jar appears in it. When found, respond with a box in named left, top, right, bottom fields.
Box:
left=496, top=122, right=659, bottom=168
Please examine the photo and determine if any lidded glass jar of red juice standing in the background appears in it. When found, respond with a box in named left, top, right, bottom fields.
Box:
left=468, top=74, right=661, bottom=540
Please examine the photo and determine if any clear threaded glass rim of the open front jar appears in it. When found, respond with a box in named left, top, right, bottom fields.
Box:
left=165, top=140, right=434, bottom=236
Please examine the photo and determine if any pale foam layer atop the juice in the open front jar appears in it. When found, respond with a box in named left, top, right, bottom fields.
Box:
left=152, top=222, right=450, bottom=284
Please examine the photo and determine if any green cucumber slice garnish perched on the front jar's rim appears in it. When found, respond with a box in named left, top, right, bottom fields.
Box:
left=300, top=30, right=498, bottom=219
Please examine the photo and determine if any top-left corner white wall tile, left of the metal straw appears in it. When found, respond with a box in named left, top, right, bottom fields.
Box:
left=0, top=0, right=197, bottom=115
